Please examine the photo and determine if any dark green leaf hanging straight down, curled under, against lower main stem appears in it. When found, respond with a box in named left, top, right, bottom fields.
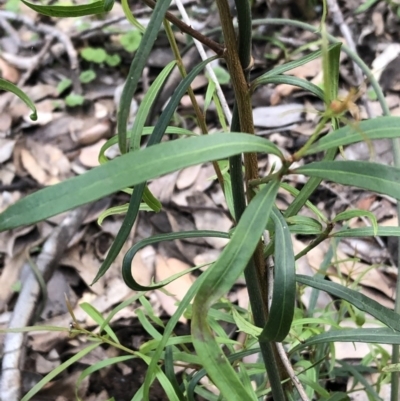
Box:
left=259, top=207, right=296, bottom=342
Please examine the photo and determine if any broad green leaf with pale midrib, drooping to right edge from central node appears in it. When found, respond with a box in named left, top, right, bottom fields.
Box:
left=294, top=161, right=400, bottom=199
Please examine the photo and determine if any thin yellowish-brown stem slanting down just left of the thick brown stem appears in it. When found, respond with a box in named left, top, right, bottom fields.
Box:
left=163, top=19, right=224, bottom=190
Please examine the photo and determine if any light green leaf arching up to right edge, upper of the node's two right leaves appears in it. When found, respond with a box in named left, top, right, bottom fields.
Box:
left=307, top=116, right=400, bottom=155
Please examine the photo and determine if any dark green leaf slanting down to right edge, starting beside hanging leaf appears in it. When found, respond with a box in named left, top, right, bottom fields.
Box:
left=296, top=274, right=400, bottom=331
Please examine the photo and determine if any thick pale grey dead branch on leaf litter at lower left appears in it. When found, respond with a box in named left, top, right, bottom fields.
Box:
left=0, top=205, right=90, bottom=401
